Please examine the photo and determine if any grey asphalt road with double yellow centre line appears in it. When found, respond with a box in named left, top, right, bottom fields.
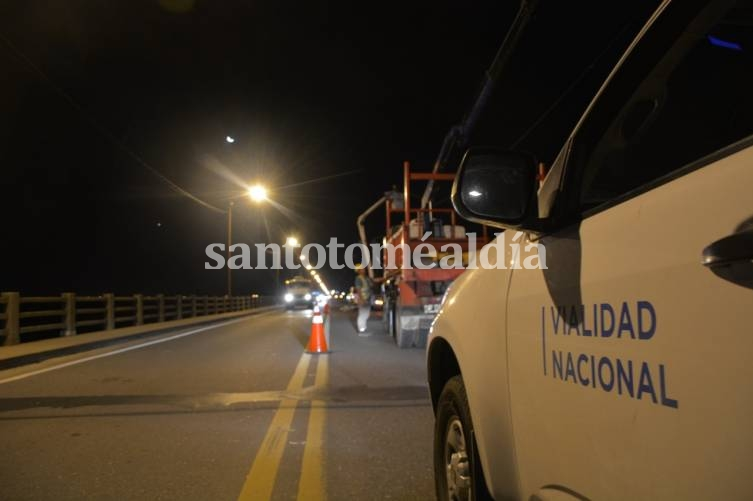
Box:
left=0, top=311, right=434, bottom=501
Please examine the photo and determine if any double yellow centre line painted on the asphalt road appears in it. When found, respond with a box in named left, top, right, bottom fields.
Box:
left=238, top=353, right=329, bottom=501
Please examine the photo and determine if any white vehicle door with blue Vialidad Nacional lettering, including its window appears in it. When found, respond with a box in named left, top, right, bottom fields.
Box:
left=507, top=2, right=753, bottom=499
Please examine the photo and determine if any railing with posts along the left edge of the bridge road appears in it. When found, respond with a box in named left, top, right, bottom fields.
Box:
left=0, top=292, right=277, bottom=346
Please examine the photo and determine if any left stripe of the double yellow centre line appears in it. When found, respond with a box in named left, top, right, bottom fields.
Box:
left=238, top=353, right=318, bottom=501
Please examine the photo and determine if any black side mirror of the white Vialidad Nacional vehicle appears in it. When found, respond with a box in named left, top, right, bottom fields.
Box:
left=452, top=148, right=536, bottom=228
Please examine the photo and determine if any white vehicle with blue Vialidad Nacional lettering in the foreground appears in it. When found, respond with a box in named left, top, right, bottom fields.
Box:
left=427, top=0, right=753, bottom=500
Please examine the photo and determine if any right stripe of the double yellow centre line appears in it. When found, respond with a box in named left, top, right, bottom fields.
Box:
left=298, top=356, right=329, bottom=501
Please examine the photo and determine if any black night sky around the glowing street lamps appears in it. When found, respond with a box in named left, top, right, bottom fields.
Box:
left=0, top=0, right=656, bottom=294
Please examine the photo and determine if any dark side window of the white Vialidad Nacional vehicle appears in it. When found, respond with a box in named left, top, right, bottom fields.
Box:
left=575, top=2, right=753, bottom=210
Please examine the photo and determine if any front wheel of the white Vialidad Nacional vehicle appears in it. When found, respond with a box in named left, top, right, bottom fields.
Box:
left=434, top=376, right=492, bottom=501
